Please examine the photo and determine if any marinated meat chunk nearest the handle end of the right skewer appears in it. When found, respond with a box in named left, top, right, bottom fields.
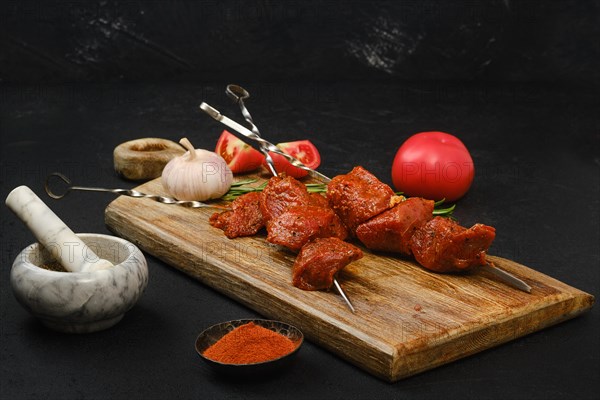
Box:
left=327, top=167, right=394, bottom=234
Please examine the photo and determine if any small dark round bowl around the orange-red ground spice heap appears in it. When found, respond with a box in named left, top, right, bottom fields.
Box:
left=196, top=319, right=304, bottom=376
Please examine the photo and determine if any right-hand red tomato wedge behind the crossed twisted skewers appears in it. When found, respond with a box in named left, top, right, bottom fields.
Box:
left=263, top=140, right=321, bottom=178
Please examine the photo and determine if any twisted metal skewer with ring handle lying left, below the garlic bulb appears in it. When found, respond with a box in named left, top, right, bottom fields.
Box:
left=44, top=172, right=231, bottom=210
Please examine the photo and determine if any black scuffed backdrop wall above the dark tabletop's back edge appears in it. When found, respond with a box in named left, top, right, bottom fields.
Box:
left=0, top=0, right=600, bottom=86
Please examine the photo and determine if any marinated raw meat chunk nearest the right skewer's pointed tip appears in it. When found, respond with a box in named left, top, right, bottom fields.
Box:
left=411, top=217, right=496, bottom=272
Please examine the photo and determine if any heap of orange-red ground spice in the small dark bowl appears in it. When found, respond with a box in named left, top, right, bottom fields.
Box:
left=202, top=322, right=296, bottom=364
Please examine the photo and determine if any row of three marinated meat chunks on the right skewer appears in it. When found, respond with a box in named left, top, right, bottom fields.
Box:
left=327, top=167, right=495, bottom=272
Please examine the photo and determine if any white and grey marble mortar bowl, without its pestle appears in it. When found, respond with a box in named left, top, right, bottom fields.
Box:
left=10, top=233, right=148, bottom=333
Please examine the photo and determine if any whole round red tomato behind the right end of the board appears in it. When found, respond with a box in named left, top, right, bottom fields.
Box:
left=392, top=132, right=475, bottom=201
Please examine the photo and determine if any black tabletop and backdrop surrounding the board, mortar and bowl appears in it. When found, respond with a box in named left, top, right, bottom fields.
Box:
left=0, top=0, right=600, bottom=399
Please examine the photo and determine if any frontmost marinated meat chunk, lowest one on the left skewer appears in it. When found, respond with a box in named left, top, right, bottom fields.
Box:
left=292, top=237, right=363, bottom=290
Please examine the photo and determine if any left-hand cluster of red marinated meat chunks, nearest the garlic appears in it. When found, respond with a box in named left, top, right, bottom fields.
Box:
left=210, top=173, right=362, bottom=290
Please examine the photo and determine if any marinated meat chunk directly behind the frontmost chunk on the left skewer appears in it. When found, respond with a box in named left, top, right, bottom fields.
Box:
left=267, top=206, right=348, bottom=251
